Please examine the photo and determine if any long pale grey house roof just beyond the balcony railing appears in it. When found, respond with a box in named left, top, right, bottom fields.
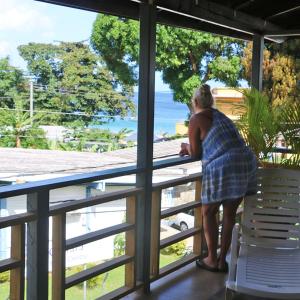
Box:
left=0, top=139, right=200, bottom=182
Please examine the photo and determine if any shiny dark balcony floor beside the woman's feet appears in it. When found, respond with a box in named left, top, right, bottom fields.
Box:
left=123, top=263, right=270, bottom=300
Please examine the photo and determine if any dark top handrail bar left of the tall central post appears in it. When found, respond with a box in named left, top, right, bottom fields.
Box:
left=0, top=165, right=144, bottom=198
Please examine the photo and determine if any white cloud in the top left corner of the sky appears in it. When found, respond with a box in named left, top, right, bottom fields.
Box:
left=0, top=0, right=53, bottom=32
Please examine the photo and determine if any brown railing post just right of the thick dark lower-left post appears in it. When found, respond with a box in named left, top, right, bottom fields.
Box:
left=52, top=213, right=66, bottom=300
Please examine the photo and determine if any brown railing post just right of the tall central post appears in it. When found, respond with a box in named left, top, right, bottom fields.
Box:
left=150, top=189, right=161, bottom=277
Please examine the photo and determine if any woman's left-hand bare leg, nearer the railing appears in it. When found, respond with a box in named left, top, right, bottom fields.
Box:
left=202, top=203, right=221, bottom=267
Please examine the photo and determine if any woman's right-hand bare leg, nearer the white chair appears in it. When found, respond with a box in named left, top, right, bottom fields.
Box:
left=218, top=198, right=242, bottom=269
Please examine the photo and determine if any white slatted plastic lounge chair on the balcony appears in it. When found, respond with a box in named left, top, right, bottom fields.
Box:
left=226, top=169, right=300, bottom=300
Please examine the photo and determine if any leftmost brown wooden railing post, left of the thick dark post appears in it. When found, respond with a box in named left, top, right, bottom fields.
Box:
left=9, top=224, right=25, bottom=300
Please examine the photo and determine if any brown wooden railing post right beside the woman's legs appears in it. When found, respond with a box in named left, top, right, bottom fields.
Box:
left=193, top=180, right=202, bottom=255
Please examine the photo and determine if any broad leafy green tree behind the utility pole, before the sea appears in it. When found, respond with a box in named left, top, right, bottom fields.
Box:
left=18, top=42, right=134, bottom=126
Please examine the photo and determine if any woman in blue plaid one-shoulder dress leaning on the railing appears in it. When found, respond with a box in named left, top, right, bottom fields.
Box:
left=180, top=84, right=256, bottom=272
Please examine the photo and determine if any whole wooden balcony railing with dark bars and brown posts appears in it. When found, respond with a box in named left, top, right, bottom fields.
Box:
left=0, top=159, right=220, bottom=299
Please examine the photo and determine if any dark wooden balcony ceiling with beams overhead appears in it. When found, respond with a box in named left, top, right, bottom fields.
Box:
left=38, top=0, right=300, bottom=42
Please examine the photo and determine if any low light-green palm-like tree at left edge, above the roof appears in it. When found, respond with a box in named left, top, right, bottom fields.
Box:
left=0, top=95, right=48, bottom=149
